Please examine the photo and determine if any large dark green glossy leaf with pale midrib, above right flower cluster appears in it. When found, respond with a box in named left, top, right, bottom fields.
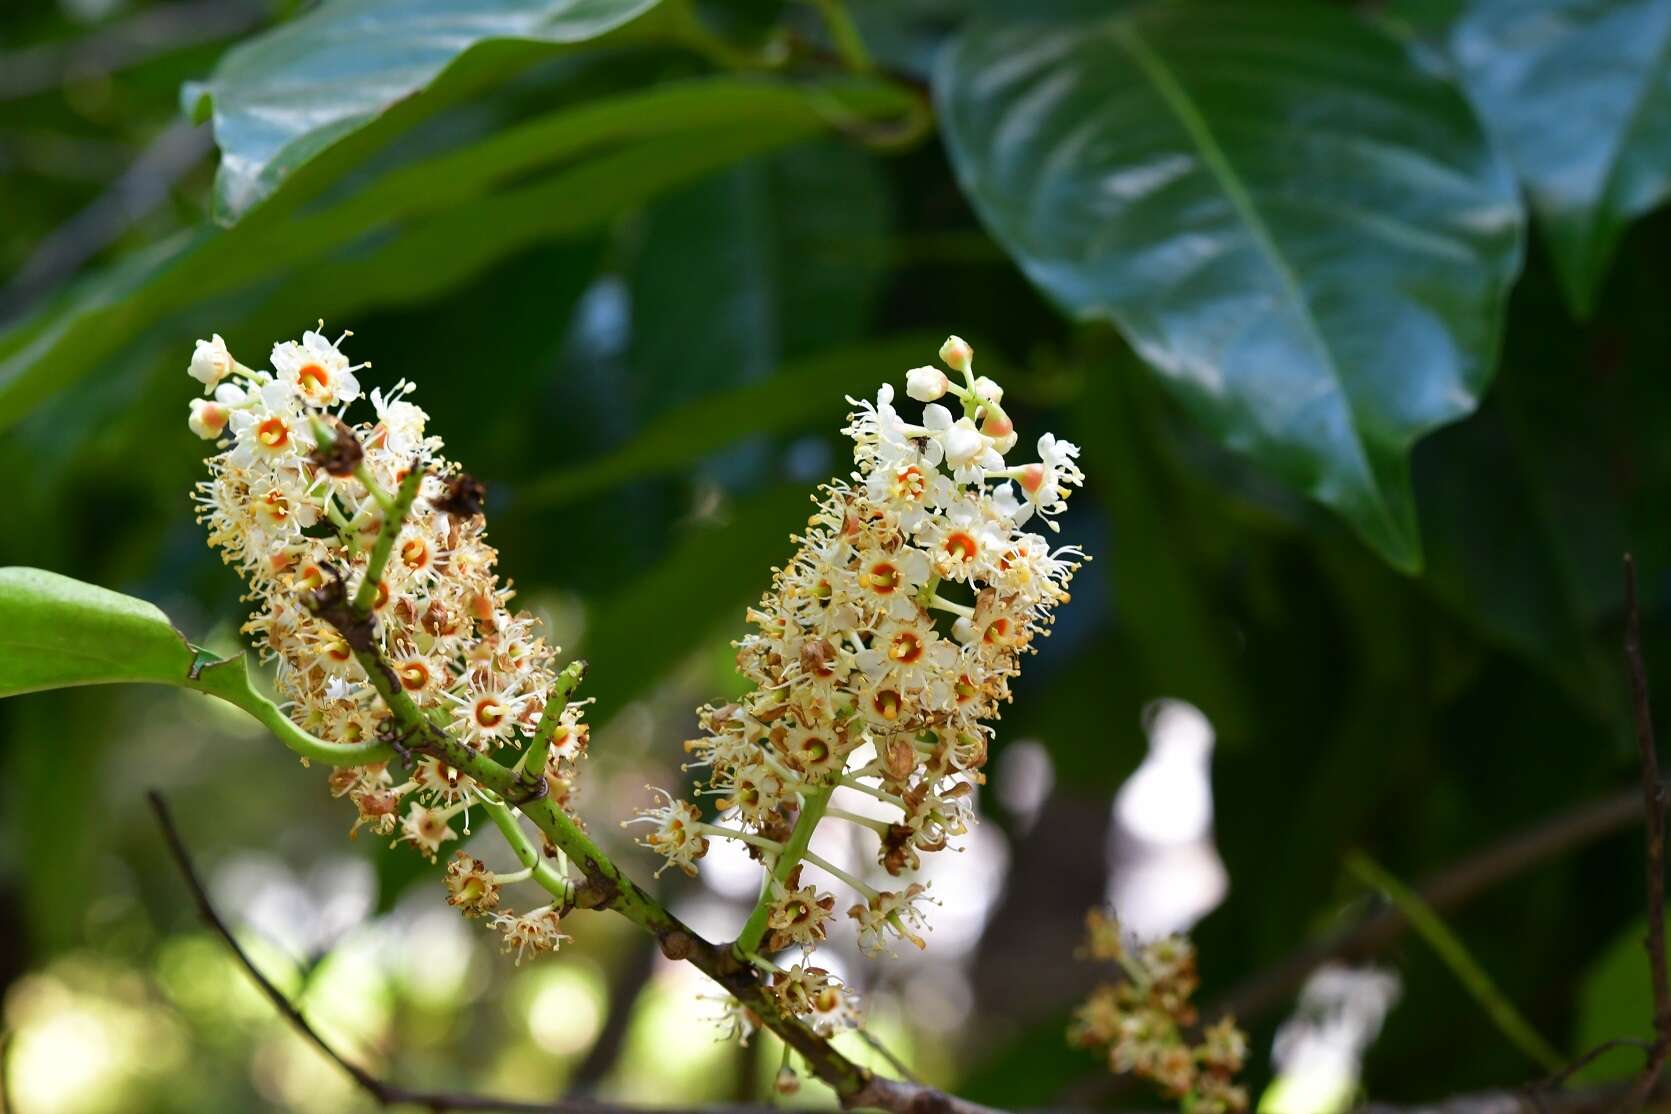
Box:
left=936, top=3, right=1522, bottom=570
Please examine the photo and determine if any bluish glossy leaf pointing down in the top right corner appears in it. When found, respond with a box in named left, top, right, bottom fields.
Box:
left=1450, top=0, right=1671, bottom=316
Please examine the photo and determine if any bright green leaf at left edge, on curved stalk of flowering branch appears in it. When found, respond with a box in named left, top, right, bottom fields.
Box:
left=0, top=568, right=197, bottom=696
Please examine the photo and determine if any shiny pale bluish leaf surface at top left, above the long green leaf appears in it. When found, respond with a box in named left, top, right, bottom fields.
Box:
left=185, top=0, right=657, bottom=222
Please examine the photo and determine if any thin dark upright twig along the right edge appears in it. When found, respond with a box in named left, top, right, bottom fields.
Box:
left=1624, top=553, right=1671, bottom=1109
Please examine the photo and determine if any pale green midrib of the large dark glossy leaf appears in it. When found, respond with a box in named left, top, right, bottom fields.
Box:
left=1108, top=17, right=1402, bottom=536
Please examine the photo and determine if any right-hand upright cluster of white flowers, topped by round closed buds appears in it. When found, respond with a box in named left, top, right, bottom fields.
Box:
left=635, top=337, right=1083, bottom=1030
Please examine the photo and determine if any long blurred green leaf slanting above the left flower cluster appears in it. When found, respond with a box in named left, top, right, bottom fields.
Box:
left=0, top=78, right=906, bottom=429
